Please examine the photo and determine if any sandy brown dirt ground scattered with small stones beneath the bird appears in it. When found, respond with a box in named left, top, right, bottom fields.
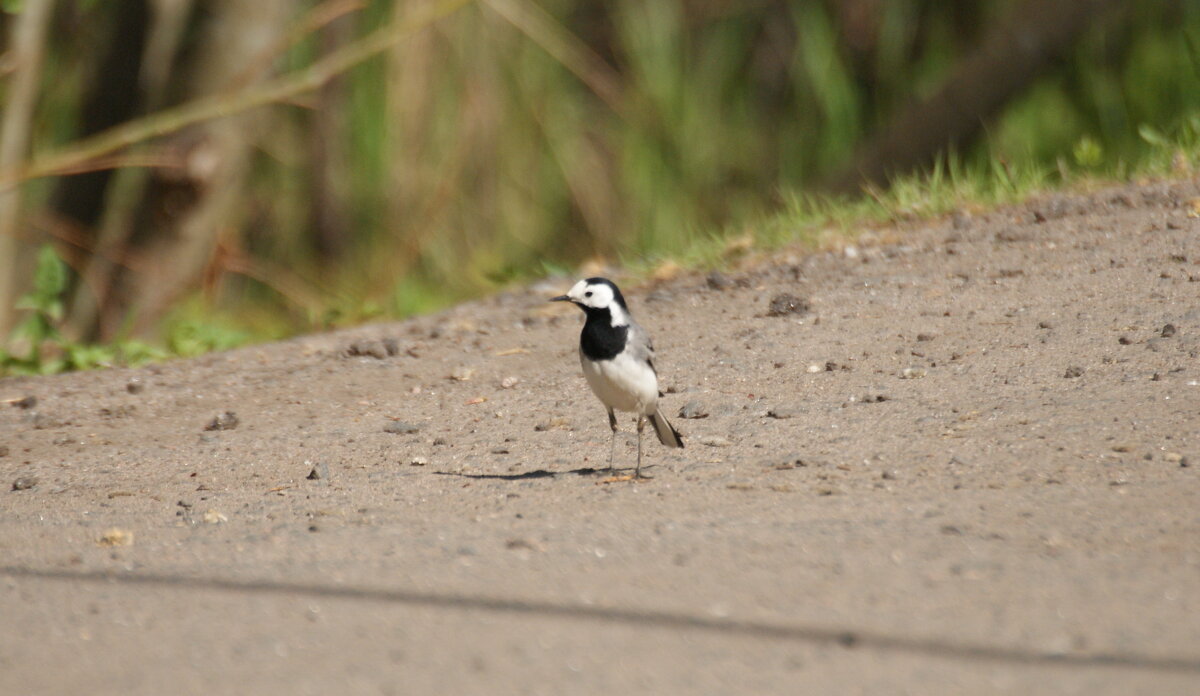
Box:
left=0, top=181, right=1200, bottom=695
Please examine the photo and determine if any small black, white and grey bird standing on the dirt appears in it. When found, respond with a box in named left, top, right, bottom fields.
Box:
left=550, top=277, right=683, bottom=479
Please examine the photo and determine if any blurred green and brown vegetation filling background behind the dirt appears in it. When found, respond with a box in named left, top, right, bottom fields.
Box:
left=0, top=0, right=1200, bottom=374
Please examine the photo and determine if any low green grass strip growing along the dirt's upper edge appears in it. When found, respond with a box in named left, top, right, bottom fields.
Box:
left=0, top=126, right=1200, bottom=377
